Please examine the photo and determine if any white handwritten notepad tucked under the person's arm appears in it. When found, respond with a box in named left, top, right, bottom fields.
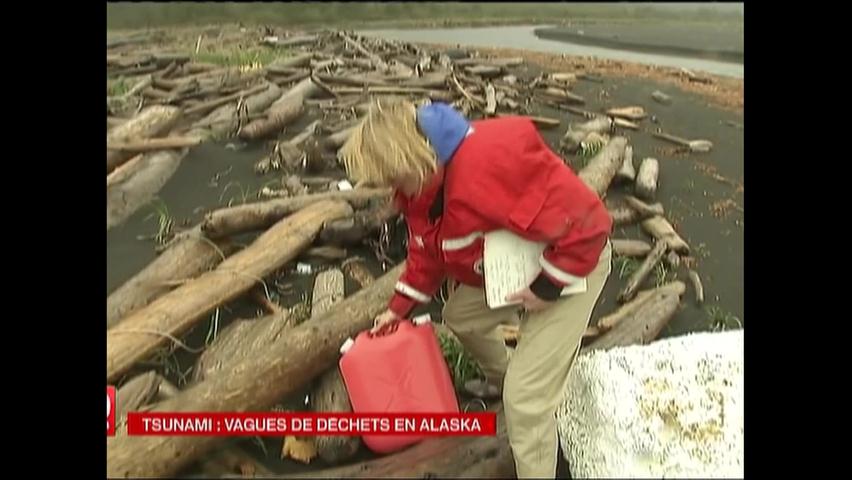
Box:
left=483, top=230, right=587, bottom=309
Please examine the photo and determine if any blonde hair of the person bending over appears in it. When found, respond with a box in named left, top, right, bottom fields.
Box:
left=340, top=97, right=438, bottom=187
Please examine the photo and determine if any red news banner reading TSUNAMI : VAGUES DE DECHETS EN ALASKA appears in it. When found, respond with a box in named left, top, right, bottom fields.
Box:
left=127, top=412, right=497, bottom=436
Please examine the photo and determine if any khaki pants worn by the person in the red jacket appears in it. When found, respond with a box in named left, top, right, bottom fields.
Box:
left=443, top=243, right=612, bottom=478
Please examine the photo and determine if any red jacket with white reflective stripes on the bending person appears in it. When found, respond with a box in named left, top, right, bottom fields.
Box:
left=389, top=117, right=612, bottom=317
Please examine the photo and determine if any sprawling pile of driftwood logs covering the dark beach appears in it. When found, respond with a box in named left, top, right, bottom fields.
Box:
left=107, top=27, right=700, bottom=477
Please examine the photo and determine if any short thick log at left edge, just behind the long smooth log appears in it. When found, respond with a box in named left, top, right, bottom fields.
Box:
left=107, top=228, right=235, bottom=327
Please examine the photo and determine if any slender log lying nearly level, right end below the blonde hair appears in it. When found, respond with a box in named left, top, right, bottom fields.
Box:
left=201, top=188, right=390, bottom=238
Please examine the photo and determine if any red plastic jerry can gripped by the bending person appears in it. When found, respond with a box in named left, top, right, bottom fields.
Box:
left=340, top=315, right=459, bottom=453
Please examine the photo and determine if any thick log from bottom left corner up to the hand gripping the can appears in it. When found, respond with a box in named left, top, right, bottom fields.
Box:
left=107, top=264, right=404, bottom=478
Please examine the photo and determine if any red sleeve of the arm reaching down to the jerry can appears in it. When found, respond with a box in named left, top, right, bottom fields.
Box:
left=388, top=221, right=444, bottom=318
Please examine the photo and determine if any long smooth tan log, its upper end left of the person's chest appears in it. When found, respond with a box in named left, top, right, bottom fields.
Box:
left=107, top=201, right=352, bottom=382
